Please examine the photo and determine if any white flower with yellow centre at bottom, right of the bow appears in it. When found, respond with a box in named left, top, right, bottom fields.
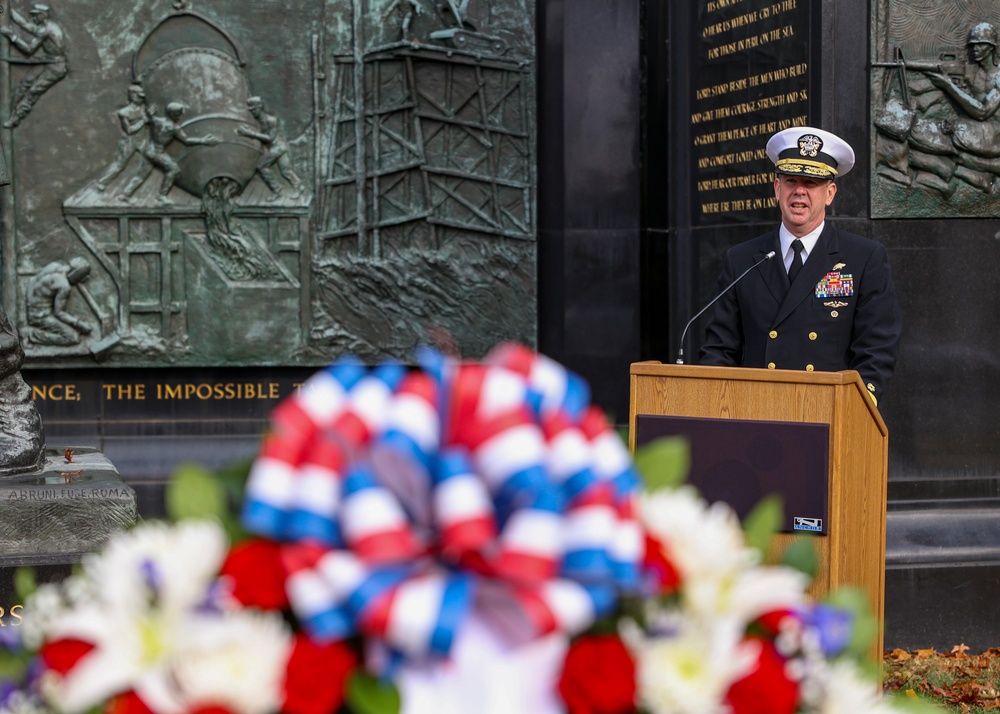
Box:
left=622, top=614, right=760, bottom=714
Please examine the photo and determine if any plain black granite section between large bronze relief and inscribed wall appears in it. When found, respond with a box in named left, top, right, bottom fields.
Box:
left=538, top=0, right=642, bottom=423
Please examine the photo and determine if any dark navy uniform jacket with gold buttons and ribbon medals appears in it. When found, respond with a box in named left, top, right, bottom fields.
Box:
left=699, top=221, right=901, bottom=399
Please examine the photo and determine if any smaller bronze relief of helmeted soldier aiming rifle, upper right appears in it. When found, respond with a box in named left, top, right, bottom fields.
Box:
left=872, top=2, right=1000, bottom=217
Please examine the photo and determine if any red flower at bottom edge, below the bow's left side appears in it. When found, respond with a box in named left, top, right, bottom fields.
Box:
left=281, top=634, right=358, bottom=714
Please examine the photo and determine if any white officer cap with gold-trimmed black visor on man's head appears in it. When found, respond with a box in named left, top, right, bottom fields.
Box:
left=767, top=126, right=854, bottom=179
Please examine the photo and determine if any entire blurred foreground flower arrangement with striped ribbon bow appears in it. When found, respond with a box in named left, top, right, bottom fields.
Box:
left=0, top=344, right=932, bottom=714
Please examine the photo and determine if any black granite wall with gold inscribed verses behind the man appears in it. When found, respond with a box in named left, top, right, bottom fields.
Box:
left=642, top=0, right=1000, bottom=651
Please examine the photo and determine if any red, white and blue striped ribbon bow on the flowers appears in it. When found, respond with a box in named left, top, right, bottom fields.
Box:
left=242, top=343, right=643, bottom=659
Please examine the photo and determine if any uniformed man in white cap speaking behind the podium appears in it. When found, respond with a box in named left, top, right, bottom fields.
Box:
left=699, top=127, right=901, bottom=404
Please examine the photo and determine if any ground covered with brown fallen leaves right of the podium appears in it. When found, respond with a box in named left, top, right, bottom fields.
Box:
left=882, top=645, right=1000, bottom=714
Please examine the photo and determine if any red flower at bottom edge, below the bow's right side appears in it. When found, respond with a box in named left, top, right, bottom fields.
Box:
left=559, top=635, right=635, bottom=714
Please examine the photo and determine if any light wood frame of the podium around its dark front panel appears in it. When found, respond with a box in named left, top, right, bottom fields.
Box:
left=629, top=362, right=889, bottom=658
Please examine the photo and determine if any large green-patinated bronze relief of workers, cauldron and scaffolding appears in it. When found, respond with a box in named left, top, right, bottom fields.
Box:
left=0, top=0, right=536, bottom=367
